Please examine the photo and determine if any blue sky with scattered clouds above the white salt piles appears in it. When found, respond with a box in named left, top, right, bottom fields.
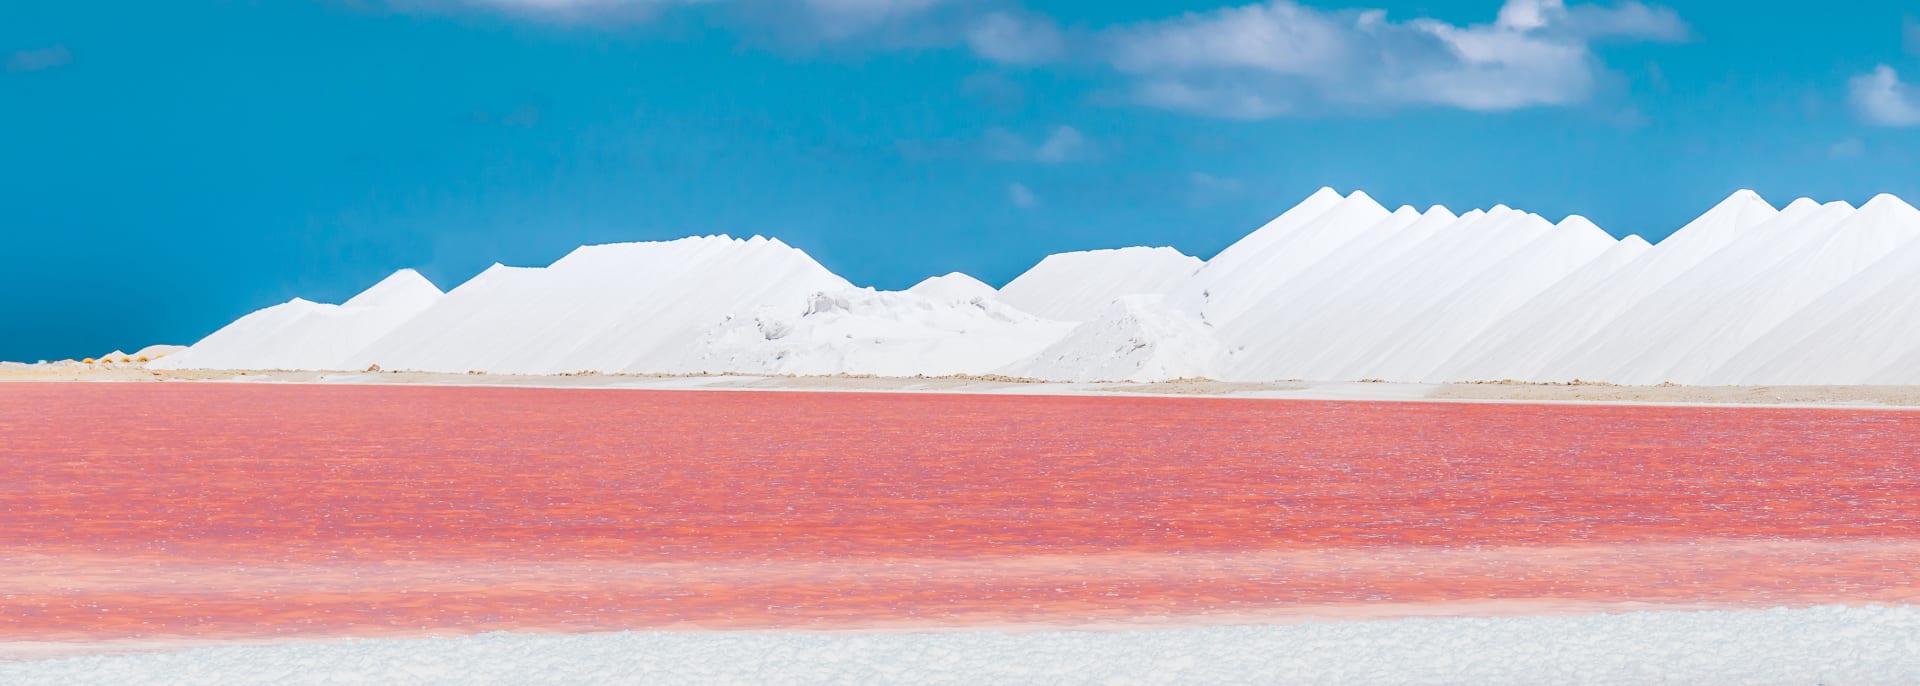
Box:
left=0, top=0, right=1920, bottom=359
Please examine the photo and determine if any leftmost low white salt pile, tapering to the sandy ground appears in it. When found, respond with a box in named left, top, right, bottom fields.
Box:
left=148, top=269, right=442, bottom=369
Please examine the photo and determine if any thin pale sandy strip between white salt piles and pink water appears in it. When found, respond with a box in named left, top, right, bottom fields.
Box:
left=0, top=363, right=1920, bottom=407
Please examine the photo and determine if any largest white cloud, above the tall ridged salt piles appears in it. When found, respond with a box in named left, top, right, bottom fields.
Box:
left=1102, top=0, right=1688, bottom=119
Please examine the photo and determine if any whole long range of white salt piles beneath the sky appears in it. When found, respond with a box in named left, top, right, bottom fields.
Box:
left=154, top=188, right=1920, bottom=384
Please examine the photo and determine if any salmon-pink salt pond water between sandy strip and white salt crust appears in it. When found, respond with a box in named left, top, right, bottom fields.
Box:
left=0, top=384, right=1920, bottom=640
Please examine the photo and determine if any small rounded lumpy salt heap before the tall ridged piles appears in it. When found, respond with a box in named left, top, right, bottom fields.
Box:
left=1002, top=296, right=1219, bottom=382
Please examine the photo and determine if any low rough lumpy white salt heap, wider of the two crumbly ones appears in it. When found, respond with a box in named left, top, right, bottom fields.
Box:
left=679, top=288, right=1073, bottom=377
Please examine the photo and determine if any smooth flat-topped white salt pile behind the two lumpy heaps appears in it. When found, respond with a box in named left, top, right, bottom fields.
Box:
left=1000, top=248, right=1202, bottom=321
